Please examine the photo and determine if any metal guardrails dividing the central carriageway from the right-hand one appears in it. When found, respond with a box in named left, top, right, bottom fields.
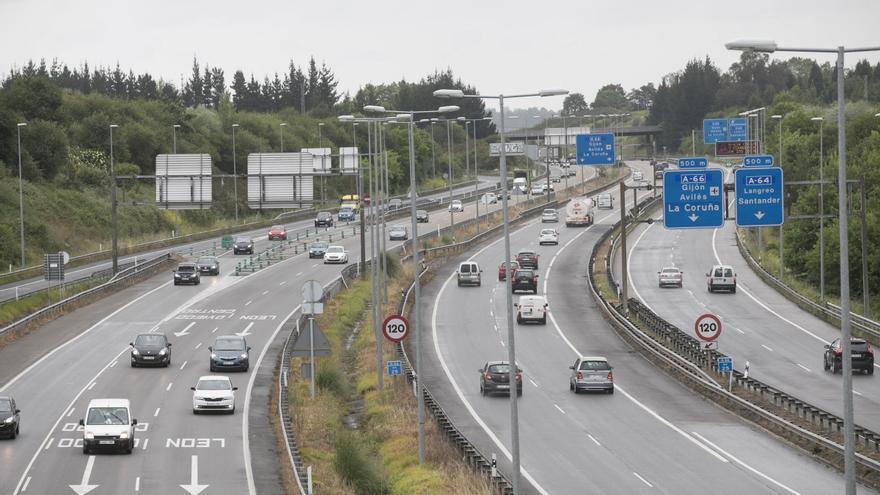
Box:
left=600, top=203, right=880, bottom=487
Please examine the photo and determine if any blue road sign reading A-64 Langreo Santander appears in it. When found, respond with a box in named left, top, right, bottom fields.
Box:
left=734, top=167, right=785, bottom=227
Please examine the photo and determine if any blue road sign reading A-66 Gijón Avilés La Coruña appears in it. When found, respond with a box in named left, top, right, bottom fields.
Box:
left=663, top=169, right=724, bottom=229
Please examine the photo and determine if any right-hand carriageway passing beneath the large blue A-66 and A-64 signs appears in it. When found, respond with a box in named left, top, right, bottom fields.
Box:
left=628, top=166, right=880, bottom=431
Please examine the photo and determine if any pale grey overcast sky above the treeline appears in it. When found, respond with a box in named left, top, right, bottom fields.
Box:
left=0, top=0, right=880, bottom=108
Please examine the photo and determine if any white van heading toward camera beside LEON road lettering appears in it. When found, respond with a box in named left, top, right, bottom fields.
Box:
left=79, top=399, right=137, bottom=454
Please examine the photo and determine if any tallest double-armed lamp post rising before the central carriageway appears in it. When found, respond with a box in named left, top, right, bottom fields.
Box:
left=434, top=89, right=568, bottom=495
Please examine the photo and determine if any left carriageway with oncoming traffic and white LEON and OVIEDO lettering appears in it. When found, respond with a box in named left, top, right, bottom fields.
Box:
left=0, top=168, right=596, bottom=495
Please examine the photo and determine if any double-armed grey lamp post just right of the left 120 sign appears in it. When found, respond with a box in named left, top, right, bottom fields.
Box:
left=364, top=105, right=459, bottom=464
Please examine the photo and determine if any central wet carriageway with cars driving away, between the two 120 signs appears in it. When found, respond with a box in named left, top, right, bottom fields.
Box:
left=421, top=162, right=868, bottom=494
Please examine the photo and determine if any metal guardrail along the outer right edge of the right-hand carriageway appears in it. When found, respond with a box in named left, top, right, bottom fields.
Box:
left=736, top=230, right=880, bottom=340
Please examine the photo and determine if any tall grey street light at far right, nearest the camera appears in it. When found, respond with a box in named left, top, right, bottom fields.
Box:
left=725, top=40, right=880, bottom=495
